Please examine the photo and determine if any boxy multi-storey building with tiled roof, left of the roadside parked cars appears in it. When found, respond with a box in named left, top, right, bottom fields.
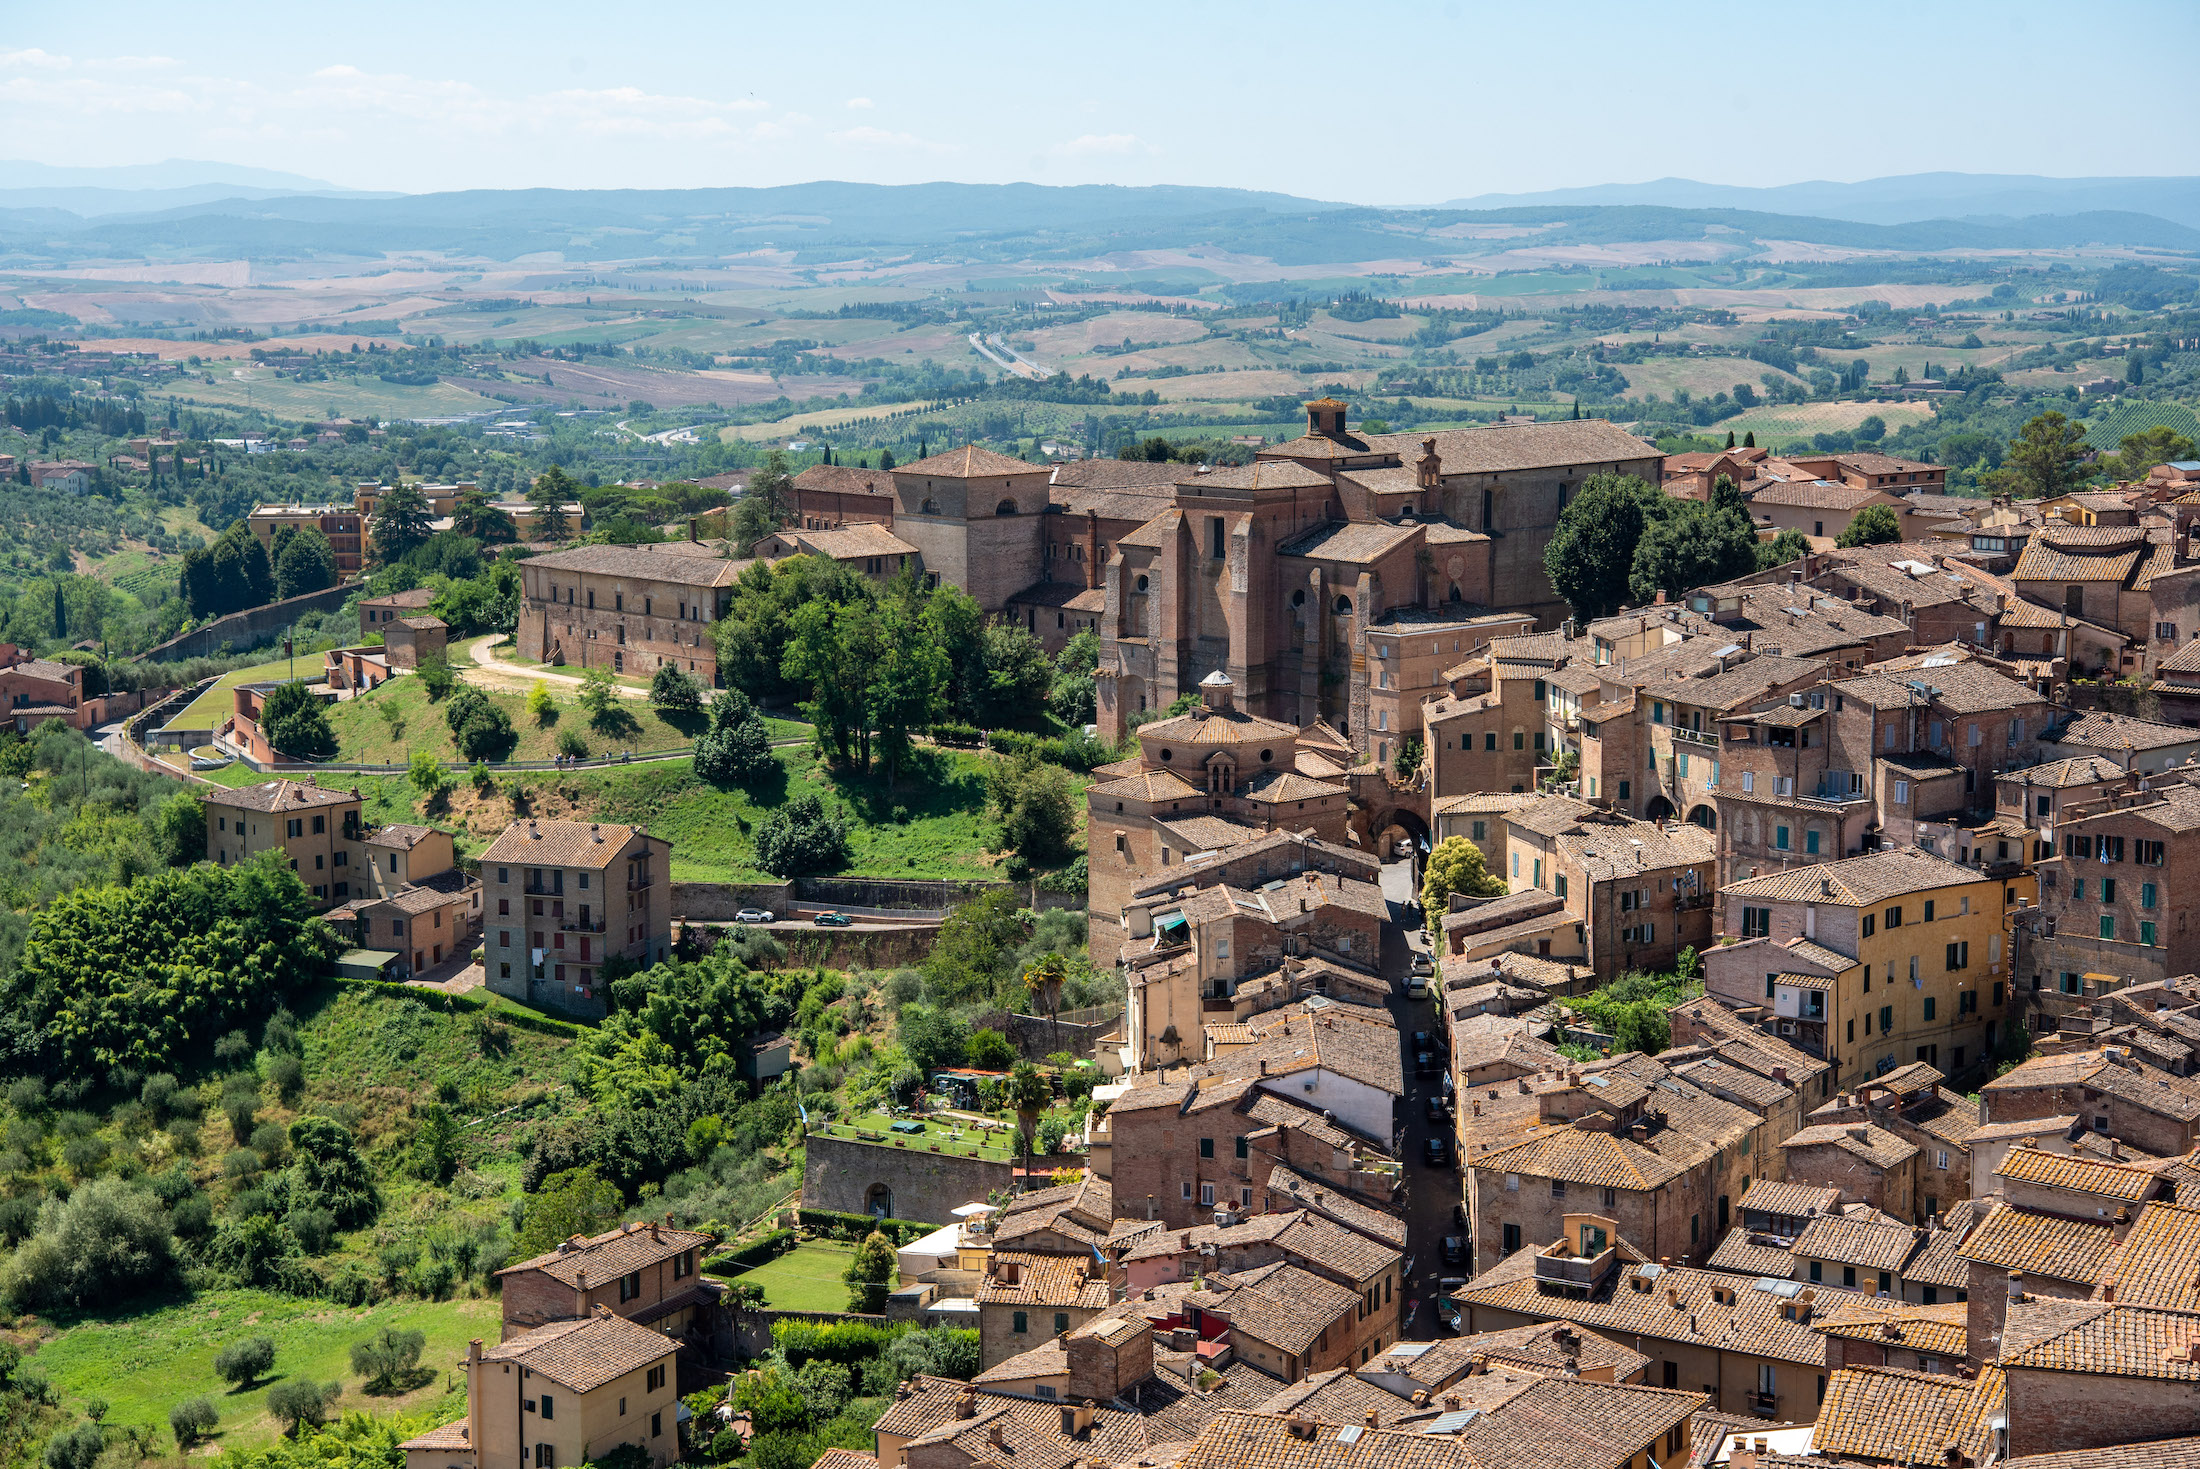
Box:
left=482, top=820, right=671, bottom=1018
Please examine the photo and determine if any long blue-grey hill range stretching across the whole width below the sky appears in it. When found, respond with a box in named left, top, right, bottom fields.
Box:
left=0, top=183, right=2200, bottom=266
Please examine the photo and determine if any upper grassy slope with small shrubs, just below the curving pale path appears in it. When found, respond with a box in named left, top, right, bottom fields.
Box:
left=328, top=677, right=706, bottom=765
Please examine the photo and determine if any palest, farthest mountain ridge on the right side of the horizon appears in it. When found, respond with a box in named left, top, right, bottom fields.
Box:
left=1443, top=174, right=2200, bottom=229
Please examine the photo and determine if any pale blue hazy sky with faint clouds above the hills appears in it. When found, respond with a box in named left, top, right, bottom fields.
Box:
left=0, top=0, right=2200, bottom=205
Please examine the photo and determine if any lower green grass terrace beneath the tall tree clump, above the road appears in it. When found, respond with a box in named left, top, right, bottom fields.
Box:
left=292, top=748, right=1085, bottom=882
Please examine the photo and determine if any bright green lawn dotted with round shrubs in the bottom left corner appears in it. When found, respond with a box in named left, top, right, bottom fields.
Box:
left=37, top=1286, right=492, bottom=1447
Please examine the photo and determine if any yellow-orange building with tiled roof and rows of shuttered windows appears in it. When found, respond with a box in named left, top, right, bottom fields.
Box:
left=1705, top=847, right=2037, bottom=1086
